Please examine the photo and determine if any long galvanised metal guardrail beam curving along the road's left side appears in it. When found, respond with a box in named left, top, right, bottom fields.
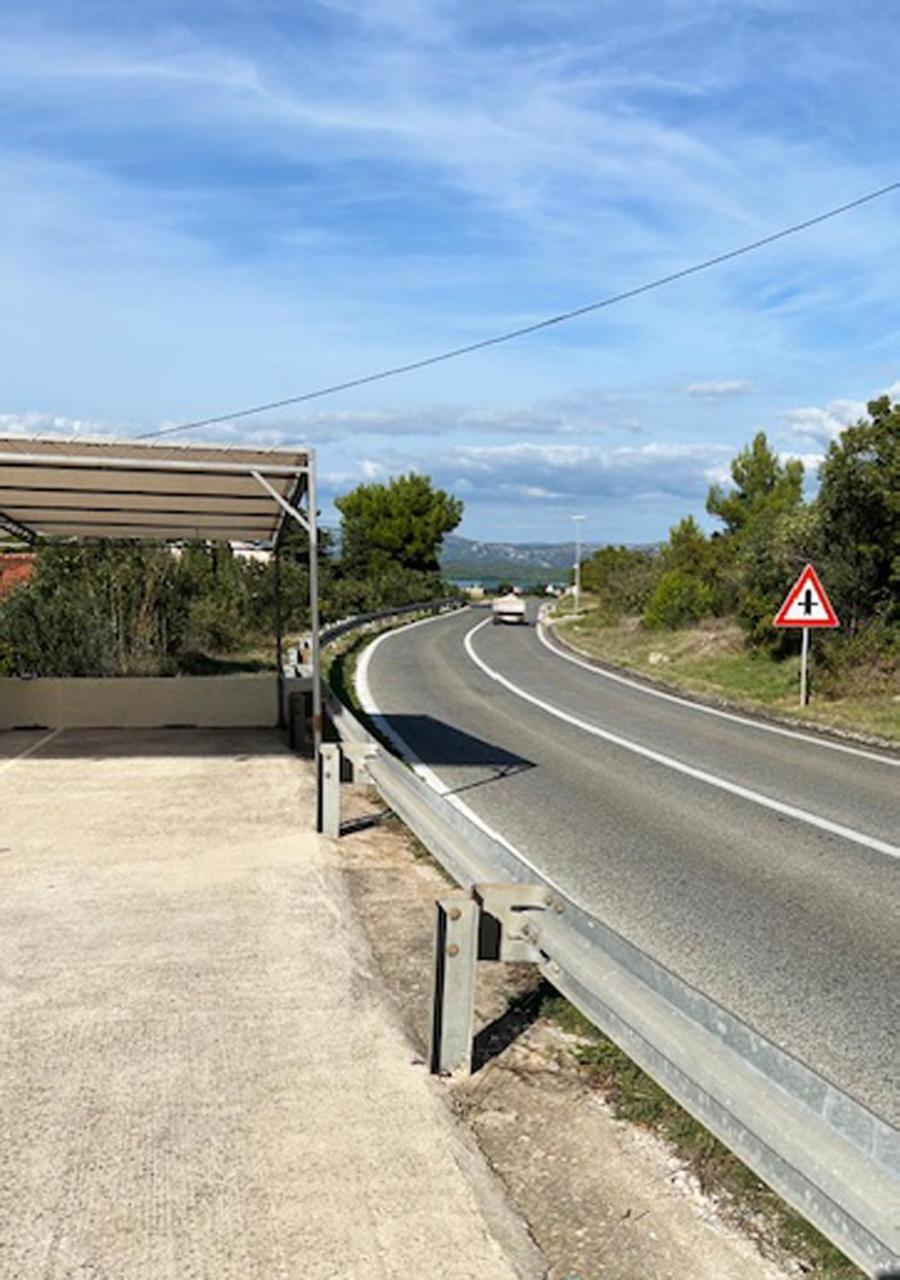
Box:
left=320, top=605, right=900, bottom=1280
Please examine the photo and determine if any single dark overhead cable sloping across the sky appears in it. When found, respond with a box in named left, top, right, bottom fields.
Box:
left=137, top=182, right=900, bottom=440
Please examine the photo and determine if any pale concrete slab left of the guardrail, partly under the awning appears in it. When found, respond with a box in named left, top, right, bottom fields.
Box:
left=0, top=731, right=540, bottom=1280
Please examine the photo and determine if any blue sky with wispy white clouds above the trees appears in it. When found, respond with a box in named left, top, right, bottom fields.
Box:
left=0, top=0, right=900, bottom=541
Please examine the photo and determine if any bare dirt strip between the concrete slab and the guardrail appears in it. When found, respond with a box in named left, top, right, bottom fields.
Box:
left=338, top=786, right=789, bottom=1280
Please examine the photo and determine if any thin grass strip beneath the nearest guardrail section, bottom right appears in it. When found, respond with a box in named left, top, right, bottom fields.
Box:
left=542, top=996, right=864, bottom=1280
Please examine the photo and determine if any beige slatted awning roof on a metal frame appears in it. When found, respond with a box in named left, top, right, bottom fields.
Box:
left=0, top=436, right=311, bottom=543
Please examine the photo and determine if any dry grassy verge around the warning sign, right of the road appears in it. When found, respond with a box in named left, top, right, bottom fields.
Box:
left=557, top=611, right=900, bottom=742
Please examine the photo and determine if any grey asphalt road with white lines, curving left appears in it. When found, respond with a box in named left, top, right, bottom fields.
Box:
left=366, top=609, right=900, bottom=1125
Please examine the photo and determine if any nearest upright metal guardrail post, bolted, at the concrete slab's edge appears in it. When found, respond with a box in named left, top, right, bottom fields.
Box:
left=429, top=893, right=479, bottom=1075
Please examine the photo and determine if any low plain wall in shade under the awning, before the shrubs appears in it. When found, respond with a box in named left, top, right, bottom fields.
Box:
left=0, top=673, right=278, bottom=730
